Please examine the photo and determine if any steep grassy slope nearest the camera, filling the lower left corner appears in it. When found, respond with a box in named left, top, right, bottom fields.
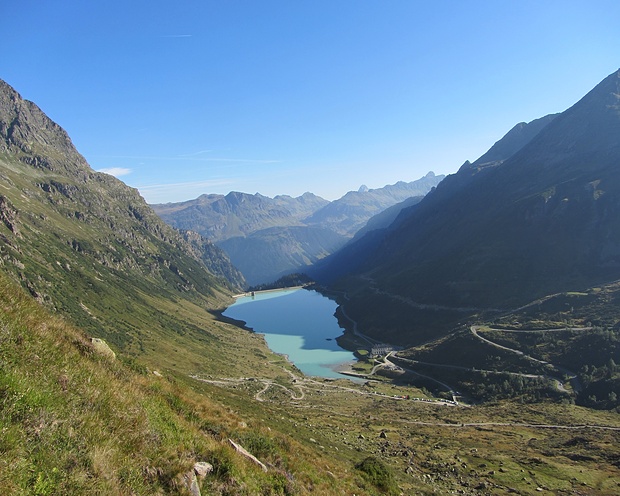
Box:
left=0, top=273, right=368, bottom=495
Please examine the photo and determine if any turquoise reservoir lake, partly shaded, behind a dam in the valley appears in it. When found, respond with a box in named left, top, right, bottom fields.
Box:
left=224, top=289, right=355, bottom=378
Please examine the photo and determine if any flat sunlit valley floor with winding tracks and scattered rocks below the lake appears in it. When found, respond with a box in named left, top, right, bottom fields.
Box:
left=189, top=356, right=620, bottom=494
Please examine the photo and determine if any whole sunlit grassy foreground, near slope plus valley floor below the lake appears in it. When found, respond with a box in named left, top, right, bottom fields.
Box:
left=0, top=275, right=620, bottom=495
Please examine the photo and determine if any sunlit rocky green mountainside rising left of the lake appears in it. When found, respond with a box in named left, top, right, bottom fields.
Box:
left=0, top=77, right=245, bottom=353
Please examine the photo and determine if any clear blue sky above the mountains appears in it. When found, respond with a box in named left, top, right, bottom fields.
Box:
left=0, top=0, right=620, bottom=203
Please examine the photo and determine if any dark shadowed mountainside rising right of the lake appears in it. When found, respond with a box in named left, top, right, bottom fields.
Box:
left=320, top=73, right=620, bottom=339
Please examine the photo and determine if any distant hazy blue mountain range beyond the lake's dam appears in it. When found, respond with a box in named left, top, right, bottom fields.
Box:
left=152, top=172, right=444, bottom=285
